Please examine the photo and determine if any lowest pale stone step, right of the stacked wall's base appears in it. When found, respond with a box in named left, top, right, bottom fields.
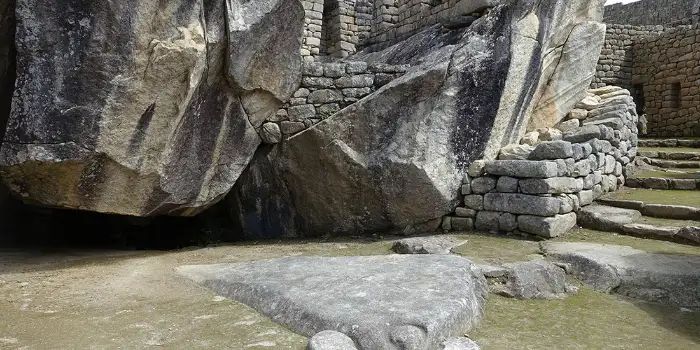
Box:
left=577, top=204, right=700, bottom=245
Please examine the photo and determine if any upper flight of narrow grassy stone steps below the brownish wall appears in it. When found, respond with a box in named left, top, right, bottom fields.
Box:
left=626, top=139, right=700, bottom=190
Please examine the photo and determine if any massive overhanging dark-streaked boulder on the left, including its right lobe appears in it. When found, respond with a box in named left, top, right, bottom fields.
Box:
left=0, top=0, right=303, bottom=216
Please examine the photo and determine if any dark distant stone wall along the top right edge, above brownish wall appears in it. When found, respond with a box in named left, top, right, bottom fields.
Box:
left=603, top=0, right=700, bottom=25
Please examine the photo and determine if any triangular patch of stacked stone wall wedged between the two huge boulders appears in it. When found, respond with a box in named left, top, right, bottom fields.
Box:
left=263, top=61, right=408, bottom=143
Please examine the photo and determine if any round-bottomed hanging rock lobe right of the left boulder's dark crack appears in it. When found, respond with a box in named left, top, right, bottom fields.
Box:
left=226, top=0, right=304, bottom=101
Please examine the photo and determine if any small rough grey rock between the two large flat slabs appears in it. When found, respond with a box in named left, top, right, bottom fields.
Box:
left=499, top=260, right=569, bottom=299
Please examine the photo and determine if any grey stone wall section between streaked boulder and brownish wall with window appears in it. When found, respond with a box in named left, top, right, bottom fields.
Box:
left=591, top=24, right=665, bottom=91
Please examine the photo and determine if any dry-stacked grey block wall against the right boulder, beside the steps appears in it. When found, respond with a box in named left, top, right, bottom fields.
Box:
left=443, top=87, right=638, bottom=237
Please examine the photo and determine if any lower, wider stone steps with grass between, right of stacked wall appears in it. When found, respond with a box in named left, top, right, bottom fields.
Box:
left=577, top=189, right=700, bottom=245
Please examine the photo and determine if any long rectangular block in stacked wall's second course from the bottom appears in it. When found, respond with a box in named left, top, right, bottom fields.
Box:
left=484, top=193, right=561, bottom=216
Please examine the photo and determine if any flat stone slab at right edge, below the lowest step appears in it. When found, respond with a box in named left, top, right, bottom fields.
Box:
left=542, top=243, right=700, bottom=309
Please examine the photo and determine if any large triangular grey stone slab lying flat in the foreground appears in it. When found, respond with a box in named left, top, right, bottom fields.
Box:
left=178, top=255, right=487, bottom=350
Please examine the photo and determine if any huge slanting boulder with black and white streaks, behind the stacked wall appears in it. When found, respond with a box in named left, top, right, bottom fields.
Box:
left=234, top=0, right=604, bottom=235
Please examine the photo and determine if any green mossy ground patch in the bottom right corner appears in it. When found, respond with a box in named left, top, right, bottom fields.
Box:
left=469, top=287, right=700, bottom=350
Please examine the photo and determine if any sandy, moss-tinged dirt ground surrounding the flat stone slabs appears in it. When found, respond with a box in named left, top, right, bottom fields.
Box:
left=0, top=232, right=700, bottom=349
